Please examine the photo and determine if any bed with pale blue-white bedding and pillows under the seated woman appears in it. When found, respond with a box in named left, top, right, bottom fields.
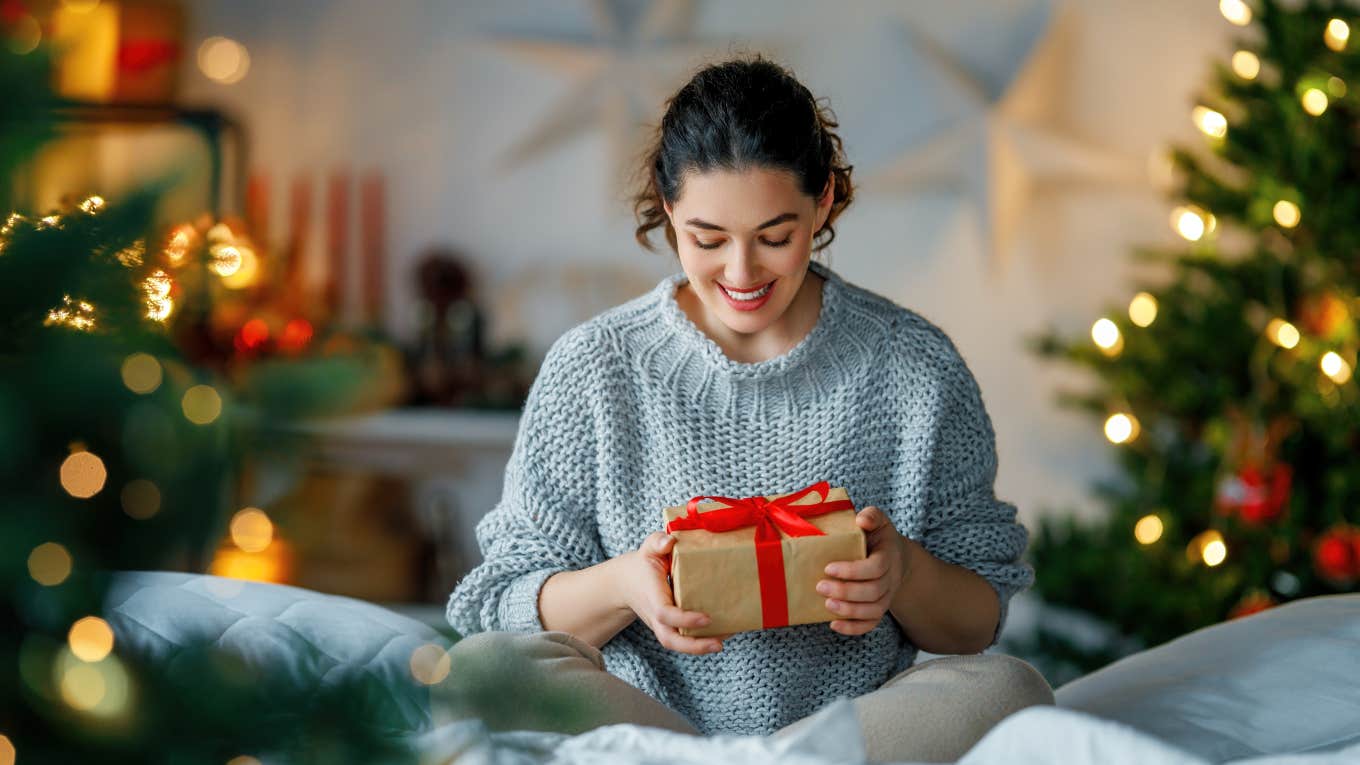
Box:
left=105, top=572, right=1360, bottom=765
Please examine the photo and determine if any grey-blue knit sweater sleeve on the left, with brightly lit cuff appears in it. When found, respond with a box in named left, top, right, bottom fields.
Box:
left=446, top=325, right=605, bottom=636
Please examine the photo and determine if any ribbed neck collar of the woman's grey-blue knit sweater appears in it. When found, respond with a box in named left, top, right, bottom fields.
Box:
left=656, top=260, right=843, bottom=378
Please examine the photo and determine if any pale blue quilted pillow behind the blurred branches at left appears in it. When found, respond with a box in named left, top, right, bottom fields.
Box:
left=105, top=572, right=449, bottom=735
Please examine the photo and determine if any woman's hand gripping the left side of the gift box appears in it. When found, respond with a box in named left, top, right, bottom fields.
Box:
left=620, top=531, right=734, bottom=653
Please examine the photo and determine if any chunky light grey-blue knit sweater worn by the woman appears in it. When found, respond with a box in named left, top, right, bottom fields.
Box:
left=447, top=255, right=1034, bottom=735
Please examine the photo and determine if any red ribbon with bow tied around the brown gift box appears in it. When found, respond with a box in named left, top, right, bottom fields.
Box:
left=666, top=481, right=854, bottom=628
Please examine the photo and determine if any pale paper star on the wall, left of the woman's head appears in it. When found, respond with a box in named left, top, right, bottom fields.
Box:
left=491, top=0, right=723, bottom=193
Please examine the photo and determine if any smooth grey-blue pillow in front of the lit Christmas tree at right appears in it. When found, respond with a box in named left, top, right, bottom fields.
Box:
left=1054, top=595, right=1360, bottom=762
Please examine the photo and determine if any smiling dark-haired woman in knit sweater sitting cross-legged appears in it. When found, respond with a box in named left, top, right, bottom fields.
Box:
left=447, top=56, right=1053, bottom=760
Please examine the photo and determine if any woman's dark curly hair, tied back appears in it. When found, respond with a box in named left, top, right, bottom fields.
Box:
left=632, top=53, right=854, bottom=252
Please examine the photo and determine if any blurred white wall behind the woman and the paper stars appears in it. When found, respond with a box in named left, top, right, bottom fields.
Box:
left=186, top=0, right=1238, bottom=530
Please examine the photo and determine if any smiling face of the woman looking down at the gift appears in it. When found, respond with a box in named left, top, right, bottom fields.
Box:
left=665, top=169, right=832, bottom=333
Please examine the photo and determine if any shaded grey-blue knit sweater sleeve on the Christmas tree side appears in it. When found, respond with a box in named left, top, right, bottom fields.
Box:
left=919, top=340, right=1034, bottom=648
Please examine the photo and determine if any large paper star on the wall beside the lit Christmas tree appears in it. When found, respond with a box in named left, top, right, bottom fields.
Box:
left=861, top=7, right=1145, bottom=267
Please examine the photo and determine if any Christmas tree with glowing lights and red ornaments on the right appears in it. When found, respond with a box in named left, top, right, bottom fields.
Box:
left=1027, top=0, right=1360, bottom=679
